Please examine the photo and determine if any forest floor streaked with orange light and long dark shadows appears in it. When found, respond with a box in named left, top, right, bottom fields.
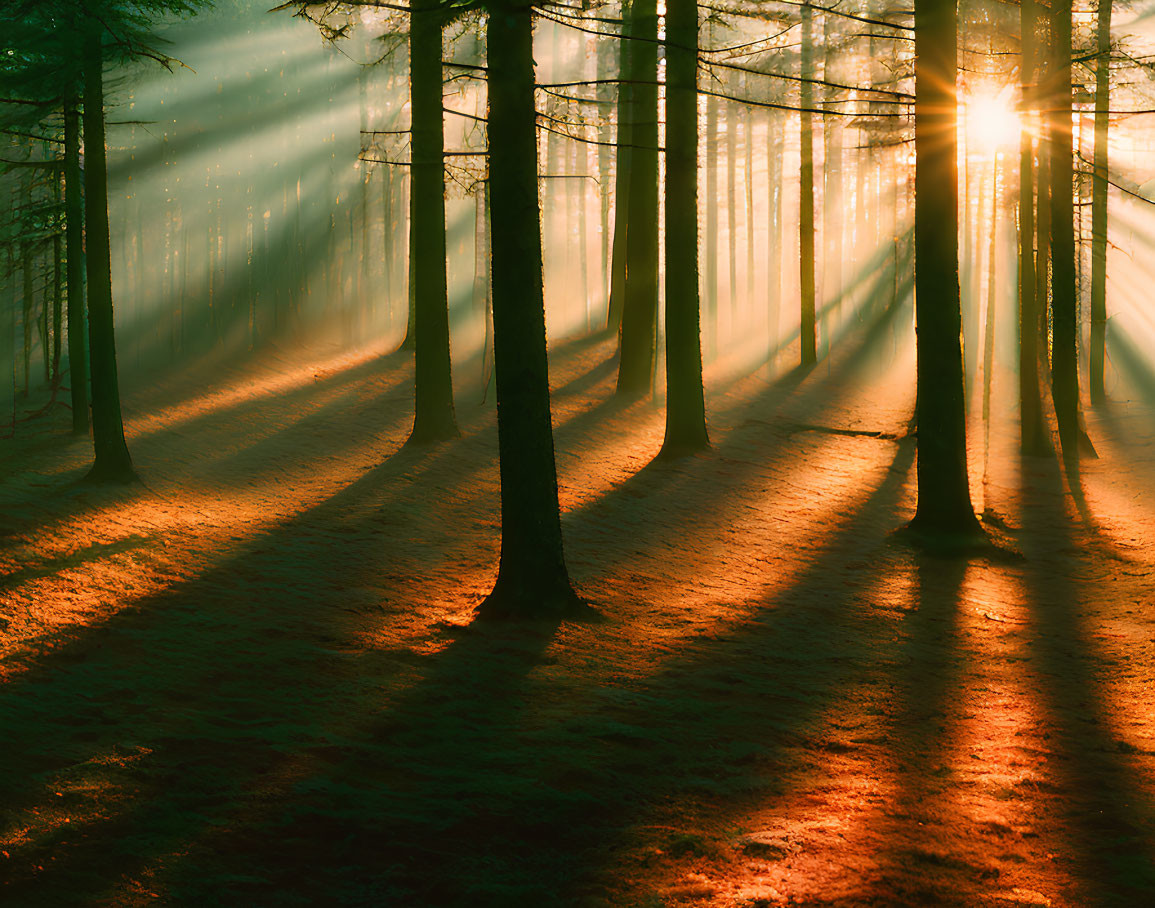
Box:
left=0, top=300, right=1155, bottom=908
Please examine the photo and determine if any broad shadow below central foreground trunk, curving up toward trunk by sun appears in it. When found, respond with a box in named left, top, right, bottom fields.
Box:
left=168, top=427, right=928, bottom=906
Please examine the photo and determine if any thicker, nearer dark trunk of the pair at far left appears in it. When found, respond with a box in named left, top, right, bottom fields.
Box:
left=84, top=31, right=136, bottom=482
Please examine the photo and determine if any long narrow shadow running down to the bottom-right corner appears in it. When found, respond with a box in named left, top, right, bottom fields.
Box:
left=1022, top=452, right=1155, bottom=906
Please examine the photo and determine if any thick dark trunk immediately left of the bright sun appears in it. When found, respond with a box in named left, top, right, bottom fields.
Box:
left=912, top=0, right=979, bottom=536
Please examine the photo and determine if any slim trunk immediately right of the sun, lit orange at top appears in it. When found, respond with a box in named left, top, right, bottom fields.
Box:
left=1019, top=0, right=1049, bottom=456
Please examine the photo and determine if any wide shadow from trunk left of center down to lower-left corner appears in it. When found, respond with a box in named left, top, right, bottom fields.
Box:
left=0, top=425, right=496, bottom=906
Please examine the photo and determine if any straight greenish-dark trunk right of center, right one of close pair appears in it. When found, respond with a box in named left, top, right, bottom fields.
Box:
left=662, top=0, right=706, bottom=456
